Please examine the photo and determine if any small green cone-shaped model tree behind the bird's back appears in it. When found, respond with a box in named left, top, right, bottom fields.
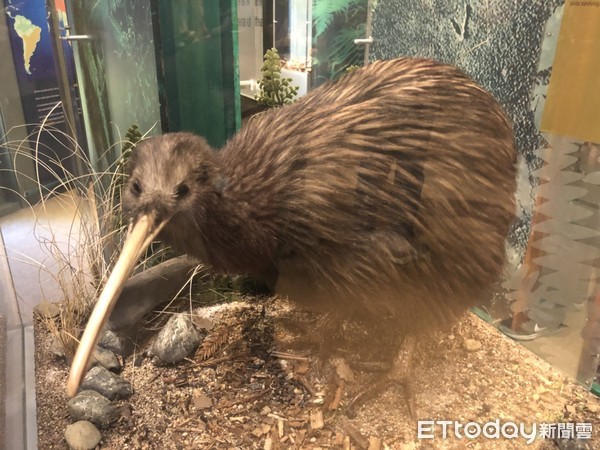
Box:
left=256, top=48, right=298, bottom=108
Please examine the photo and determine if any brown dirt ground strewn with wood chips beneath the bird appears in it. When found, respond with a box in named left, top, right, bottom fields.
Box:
left=36, top=299, right=600, bottom=450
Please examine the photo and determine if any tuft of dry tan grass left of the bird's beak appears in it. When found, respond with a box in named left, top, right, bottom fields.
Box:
left=0, top=115, right=166, bottom=361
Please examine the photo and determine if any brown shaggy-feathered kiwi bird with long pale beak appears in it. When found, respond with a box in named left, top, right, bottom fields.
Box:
left=68, top=58, right=516, bottom=395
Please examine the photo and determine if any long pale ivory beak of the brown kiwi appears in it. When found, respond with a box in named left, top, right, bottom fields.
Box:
left=67, top=215, right=167, bottom=397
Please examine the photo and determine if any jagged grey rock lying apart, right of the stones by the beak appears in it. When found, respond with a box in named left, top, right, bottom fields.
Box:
left=150, top=313, right=205, bottom=364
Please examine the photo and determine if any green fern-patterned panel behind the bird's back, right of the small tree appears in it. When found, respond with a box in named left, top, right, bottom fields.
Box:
left=312, top=0, right=368, bottom=85
